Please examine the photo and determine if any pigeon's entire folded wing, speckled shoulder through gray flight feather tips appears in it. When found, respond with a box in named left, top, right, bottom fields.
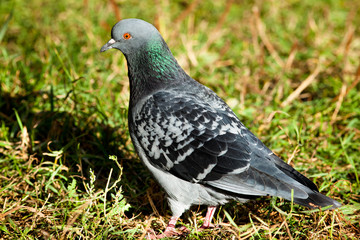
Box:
left=134, top=87, right=316, bottom=197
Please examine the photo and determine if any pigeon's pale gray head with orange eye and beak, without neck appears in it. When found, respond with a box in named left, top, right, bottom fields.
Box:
left=100, top=18, right=162, bottom=56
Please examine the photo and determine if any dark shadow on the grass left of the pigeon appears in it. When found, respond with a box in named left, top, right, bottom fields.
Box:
left=0, top=91, right=158, bottom=217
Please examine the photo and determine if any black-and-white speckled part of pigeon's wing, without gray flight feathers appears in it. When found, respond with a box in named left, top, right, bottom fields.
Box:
left=135, top=88, right=253, bottom=178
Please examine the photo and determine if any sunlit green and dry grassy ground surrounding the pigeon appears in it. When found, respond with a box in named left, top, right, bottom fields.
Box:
left=0, top=0, right=360, bottom=239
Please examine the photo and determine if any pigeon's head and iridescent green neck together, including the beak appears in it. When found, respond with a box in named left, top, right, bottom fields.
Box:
left=100, top=19, right=190, bottom=103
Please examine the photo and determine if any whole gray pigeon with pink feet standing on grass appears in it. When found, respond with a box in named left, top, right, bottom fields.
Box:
left=100, top=18, right=341, bottom=239
